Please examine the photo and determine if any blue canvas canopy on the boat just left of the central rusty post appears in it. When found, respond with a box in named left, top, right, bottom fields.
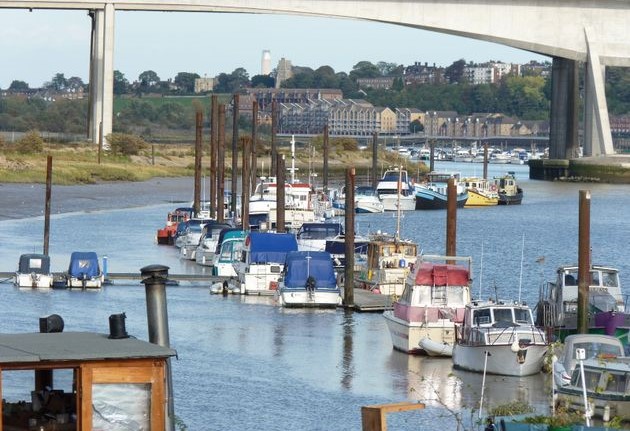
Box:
left=284, top=251, right=337, bottom=289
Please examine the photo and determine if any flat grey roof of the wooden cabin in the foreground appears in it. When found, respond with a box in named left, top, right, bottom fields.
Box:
left=0, top=332, right=177, bottom=364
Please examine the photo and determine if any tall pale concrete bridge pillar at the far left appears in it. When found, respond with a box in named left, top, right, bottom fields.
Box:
left=88, top=3, right=115, bottom=143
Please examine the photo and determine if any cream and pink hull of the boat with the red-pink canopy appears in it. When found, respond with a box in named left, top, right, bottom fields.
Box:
left=383, top=310, right=455, bottom=356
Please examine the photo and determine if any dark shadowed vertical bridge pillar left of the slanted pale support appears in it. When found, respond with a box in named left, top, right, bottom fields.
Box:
left=549, top=57, right=579, bottom=159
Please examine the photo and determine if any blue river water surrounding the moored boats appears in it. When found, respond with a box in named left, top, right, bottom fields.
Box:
left=0, top=162, right=630, bottom=431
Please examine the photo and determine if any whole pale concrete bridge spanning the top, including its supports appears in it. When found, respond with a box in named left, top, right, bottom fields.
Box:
left=0, top=0, right=630, bottom=159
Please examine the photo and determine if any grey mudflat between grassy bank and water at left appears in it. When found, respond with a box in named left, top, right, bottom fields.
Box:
left=0, top=177, right=194, bottom=220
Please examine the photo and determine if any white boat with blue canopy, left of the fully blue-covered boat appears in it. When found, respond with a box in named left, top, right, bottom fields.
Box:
left=228, top=232, right=297, bottom=295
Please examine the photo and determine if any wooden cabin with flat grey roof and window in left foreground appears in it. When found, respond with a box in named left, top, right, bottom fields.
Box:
left=0, top=330, right=176, bottom=431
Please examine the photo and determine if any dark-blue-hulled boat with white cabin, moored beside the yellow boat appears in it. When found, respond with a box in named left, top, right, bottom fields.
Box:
left=414, top=172, right=468, bottom=210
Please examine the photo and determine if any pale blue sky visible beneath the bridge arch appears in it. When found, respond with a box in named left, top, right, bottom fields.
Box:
left=0, top=9, right=549, bottom=88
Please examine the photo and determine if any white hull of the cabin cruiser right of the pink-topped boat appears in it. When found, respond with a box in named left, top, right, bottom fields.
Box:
left=453, top=343, right=547, bottom=377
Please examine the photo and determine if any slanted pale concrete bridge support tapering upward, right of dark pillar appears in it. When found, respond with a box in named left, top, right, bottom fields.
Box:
left=584, top=30, right=615, bottom=156
